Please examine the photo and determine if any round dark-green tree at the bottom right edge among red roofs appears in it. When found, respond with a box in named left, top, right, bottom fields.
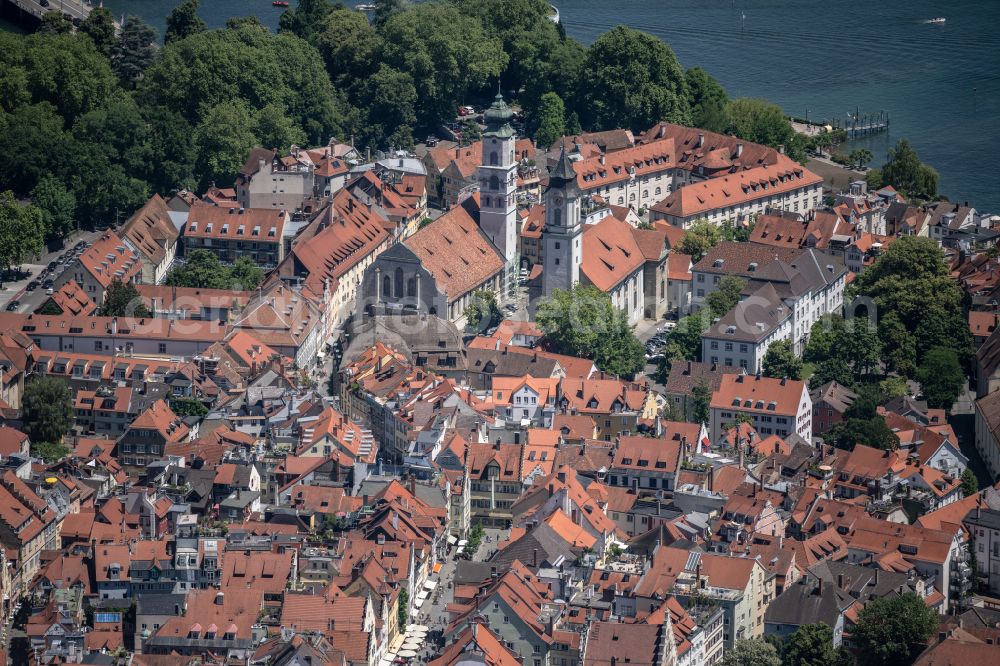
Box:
left=853, top=592, right=938, bottom=666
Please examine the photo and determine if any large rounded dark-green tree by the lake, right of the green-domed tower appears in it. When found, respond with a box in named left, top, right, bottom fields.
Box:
left=576, top=25, right=691, bottom=132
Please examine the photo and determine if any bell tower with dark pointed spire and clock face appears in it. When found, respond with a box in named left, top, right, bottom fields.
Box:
left=542, top=148, right=583, bottom=296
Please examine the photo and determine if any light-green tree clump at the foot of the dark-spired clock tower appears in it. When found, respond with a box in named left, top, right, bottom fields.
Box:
left=535, top=285, right=645, bottom=377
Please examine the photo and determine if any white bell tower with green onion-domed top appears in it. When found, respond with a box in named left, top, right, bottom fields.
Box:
left=476, top=93, right=518, bottom=290
